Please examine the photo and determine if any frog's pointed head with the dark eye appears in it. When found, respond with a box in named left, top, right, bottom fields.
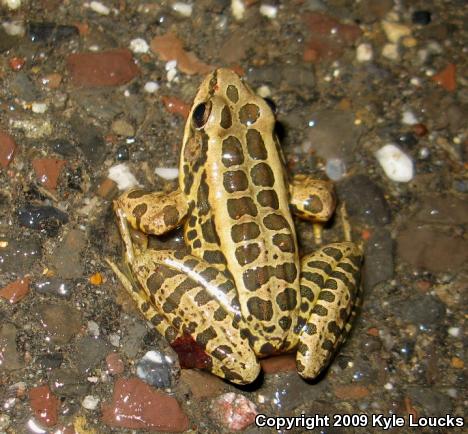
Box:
left=179, top=69, right=275, bottom=193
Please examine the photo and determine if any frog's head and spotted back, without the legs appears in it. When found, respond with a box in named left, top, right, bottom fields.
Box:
left=180, top=70, right=299, bottom=355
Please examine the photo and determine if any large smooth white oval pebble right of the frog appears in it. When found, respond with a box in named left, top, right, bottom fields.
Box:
left=375, top=143, right=414, bottom=182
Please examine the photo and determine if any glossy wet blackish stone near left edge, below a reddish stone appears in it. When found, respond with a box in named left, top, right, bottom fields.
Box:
left=18, top=204, right=68, bottom=237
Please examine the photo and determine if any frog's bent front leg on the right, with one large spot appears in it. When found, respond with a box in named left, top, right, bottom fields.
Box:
left=289, top=175, right=336, bottom=222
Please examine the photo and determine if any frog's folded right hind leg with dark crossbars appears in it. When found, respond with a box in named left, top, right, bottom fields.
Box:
left=296, top=242, right=362, bottom=378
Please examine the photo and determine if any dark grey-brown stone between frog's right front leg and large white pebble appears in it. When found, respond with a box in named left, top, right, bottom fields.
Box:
left=337, top=175, right=391, bottom=226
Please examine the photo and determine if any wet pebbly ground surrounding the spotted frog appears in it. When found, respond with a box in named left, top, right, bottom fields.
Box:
left=0, top=0, right=468, bottom=434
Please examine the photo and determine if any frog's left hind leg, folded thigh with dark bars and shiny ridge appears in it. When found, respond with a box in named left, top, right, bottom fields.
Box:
left=132, top=250, right=260, bottom=384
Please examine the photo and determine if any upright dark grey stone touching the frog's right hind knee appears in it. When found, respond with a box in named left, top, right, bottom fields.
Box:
left=363, top=228, right=394, bottom=290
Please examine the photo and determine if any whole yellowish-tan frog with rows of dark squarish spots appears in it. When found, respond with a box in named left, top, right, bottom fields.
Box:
left=111, top=69, right=362, bottom=384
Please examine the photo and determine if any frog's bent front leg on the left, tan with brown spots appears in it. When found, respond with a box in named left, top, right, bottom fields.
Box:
left=114, top=189, right=188, bottom=235
